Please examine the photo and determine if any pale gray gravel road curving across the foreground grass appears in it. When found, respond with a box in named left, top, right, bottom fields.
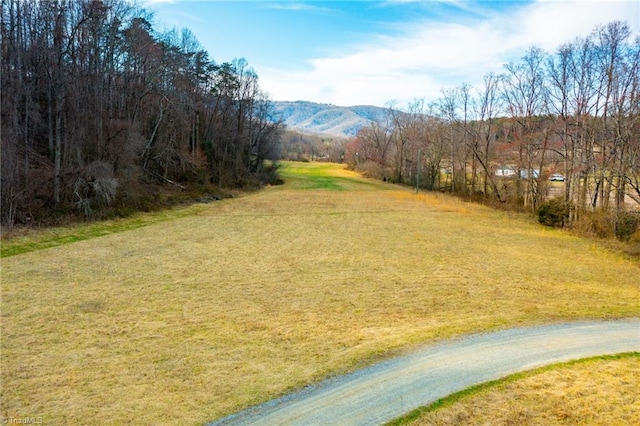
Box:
left=211, top=319, right=640, bottom=425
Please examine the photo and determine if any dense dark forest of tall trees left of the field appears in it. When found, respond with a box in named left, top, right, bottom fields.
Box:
left=0, top=0, right=282, bottom=225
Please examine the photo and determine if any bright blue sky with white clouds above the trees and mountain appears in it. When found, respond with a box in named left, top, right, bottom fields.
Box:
left=142, top=0, right=640, bottom=107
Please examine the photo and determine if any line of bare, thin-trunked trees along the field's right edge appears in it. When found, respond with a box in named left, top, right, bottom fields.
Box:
left=346, top=21, right=640, bottom=230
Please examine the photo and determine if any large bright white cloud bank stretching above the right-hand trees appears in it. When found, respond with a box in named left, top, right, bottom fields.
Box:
left=260, top=1, right=640, bottom=106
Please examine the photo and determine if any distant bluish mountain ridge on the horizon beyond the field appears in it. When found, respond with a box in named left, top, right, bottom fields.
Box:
left=274, top=101, right=388, bottom=137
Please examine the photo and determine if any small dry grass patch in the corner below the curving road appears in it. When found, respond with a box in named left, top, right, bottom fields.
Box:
left=410, top=357, right=640, bottom=426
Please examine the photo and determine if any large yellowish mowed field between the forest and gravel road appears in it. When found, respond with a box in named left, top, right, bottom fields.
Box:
left=1, top=163, right=640, bottom=424
